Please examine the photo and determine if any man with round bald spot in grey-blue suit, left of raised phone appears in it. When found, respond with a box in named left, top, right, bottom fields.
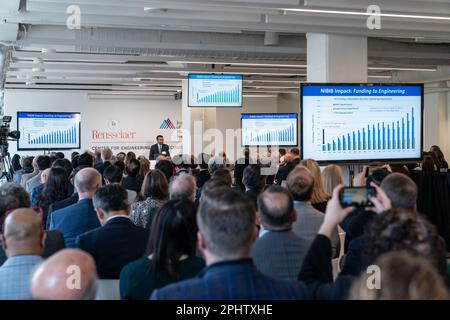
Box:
left=252, top=186, right=309, bottom=281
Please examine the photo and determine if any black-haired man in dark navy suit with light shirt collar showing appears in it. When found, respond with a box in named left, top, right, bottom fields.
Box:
left=76, top=184, right=148, bottom=279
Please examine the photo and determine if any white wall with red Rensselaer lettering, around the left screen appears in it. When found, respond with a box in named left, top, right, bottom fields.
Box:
left=5, top=90, right=181, bottom=156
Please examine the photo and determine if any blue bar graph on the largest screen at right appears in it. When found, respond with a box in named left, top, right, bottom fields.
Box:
left=322, top=109, right=416, bottom=151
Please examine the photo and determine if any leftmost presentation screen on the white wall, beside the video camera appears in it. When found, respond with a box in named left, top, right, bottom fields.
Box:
left=17, top=112, right=81, bottom=150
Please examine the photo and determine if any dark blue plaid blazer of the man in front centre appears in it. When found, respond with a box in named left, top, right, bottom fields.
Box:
left=151, top=259, right=307, bottom=300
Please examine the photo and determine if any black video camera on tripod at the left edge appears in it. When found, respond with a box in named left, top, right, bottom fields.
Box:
left=0, top=116, right=20, bottom=181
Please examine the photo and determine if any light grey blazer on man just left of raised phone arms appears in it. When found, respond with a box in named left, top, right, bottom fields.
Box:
left=292, top=201, right=341, bottom=258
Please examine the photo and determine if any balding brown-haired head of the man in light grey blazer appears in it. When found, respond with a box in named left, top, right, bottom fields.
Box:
left=286, top=166, right=314, bottom=201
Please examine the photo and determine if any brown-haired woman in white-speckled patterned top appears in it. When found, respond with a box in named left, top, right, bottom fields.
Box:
left=130, top=169, right=169, bottom=231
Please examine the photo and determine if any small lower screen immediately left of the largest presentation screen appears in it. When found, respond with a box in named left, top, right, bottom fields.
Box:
left=241, top=113, right=298, bottom=147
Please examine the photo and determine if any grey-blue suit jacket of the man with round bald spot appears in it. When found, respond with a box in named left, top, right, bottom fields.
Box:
left=252, top=231, right=309, bottom=281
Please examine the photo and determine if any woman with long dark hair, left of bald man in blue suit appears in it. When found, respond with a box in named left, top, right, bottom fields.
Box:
left=34, top=168, right=72, bottom=229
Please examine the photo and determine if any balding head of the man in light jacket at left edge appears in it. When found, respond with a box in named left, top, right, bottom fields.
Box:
left=2, top=208, right=44, bottom=258
